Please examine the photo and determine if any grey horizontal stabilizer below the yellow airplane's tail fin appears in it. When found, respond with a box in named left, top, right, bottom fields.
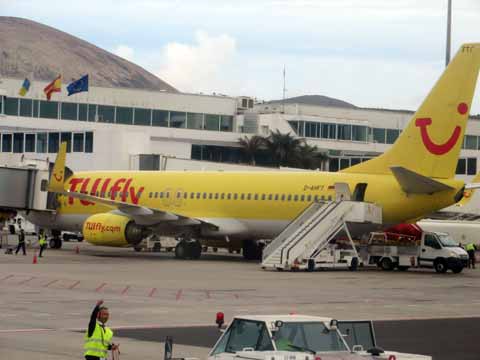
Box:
left=390, top=166, right=452, bottom=194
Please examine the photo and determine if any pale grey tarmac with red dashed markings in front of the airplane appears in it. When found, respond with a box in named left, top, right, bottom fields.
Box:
left=0, top=242, right=480, bottom=360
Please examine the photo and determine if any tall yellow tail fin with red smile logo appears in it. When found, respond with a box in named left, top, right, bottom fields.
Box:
left=343, top=43, right=480, bottom=179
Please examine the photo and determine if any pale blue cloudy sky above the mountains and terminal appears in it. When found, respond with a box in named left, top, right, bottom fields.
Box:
left=0, top=0, right=480, bottom=114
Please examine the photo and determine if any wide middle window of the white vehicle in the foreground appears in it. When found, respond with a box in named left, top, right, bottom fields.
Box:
left=274, top=322, right=348, bottom=352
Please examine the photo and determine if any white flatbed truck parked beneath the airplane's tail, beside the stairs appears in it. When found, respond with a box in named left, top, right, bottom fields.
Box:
left=359, top=231, right=468, bottom=273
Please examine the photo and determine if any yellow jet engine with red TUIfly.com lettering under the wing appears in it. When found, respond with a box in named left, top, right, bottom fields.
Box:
left=83, top=213, right=147, bottom=247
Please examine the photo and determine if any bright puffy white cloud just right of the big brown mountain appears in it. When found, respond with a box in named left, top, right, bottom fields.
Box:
left=154, top=31, right=237, bottom=92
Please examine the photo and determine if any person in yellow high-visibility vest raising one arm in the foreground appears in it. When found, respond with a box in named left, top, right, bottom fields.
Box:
left=83, top=300, right=119, bottom=360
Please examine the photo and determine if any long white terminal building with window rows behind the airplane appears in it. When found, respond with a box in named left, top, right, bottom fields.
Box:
left=0, top=78, right=480, bottom=186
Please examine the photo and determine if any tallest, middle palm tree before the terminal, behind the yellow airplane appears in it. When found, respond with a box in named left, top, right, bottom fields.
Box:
left=266, top=129, right=305, bottom=166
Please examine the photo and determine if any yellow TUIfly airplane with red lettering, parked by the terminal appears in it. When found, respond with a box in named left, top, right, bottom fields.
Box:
left=29, top=44, right=480, bottom=258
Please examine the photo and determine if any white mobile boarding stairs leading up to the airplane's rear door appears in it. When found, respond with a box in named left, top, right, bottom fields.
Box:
left=262, top=186, right=382, bottom=270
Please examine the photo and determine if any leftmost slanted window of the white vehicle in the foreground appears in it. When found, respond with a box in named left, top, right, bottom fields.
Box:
left=212, top=319, right=273, bottom=355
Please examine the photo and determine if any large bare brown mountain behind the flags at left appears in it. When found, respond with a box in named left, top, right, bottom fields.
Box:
left=0, top=16, right=178, bottom=92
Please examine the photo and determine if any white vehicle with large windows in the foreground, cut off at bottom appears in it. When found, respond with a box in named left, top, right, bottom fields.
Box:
left=208, top=314, right=432, bottom=360
